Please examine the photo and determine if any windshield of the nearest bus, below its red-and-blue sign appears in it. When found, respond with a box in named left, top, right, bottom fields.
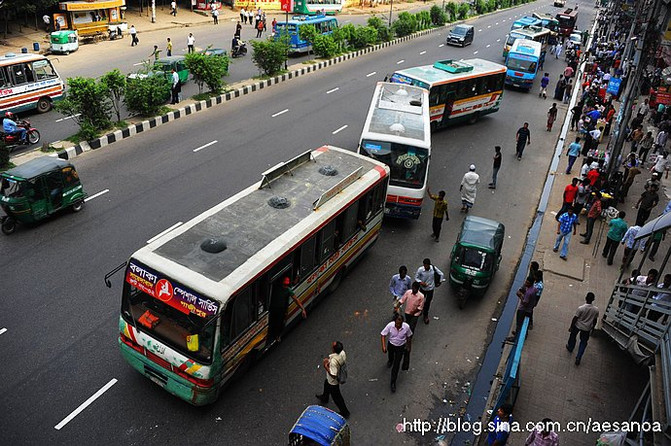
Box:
left=121, top=282, right=216, bottom=363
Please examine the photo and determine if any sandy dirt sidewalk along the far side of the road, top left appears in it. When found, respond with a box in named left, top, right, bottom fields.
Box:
left=0, top=0, right=430, bottom=55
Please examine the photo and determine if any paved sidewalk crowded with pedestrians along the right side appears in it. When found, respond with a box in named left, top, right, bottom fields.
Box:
left=509, top=103, right=669, bottom=445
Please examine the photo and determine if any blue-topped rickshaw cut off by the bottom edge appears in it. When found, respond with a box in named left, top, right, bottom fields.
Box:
left=289, top=405, right=350, bottom=446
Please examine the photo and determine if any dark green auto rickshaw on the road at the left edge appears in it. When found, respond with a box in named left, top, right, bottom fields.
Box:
left=0, top=157, right=86, bottom=235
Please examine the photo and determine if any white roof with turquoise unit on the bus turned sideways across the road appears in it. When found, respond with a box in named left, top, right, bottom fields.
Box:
left=397, top=59, right=506, bottom=85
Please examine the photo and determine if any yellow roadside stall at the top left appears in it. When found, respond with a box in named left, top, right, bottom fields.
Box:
left=54, top=0, right=127, bottom=40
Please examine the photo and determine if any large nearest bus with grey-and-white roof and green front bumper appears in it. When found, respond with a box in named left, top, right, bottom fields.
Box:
left=119, top=146, right=389, bottom=405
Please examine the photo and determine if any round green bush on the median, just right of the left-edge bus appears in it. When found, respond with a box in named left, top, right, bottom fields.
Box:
left=54, top=77, right=112, bottom=139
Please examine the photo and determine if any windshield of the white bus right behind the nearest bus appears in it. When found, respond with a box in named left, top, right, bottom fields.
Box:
left=361, top=139, right=429, bottom=189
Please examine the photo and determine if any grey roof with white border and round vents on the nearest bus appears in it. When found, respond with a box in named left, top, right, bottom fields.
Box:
left=132, top=146, right=389, bottom=302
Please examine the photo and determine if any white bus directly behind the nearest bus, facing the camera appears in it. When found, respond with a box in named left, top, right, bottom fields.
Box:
left=359, top=82, right=431, bottom=219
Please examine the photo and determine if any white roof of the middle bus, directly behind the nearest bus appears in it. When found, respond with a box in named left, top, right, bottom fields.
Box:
left=362, top=82, right=431, bottom=148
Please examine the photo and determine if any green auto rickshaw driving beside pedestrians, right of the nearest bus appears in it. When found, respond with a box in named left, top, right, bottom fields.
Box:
left=450, top=215, right=506, bottom=308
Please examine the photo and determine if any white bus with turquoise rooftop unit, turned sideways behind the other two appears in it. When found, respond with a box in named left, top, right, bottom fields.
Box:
left=391, top=59, right=506, bottom=130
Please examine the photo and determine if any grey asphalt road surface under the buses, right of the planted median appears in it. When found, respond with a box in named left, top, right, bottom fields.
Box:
left=0, top=1, right=593, bottom=445
